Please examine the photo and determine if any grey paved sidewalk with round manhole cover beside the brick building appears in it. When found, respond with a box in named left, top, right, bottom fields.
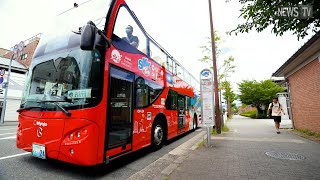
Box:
left=168, top=116, right=320, bottom=180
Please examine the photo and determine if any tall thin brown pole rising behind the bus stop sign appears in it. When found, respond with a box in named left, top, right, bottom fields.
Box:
left=208, top=0, right=221, bottom=134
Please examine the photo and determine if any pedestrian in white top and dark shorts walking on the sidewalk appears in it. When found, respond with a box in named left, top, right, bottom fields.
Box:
left=268, top=97, right=285, bottom=134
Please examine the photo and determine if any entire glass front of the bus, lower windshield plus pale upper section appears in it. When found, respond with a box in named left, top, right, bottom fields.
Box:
left=21, top=0, right=110, bottom=110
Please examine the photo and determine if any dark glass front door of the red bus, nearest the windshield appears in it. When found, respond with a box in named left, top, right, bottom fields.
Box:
left=106, top=67, right=134, bottom=158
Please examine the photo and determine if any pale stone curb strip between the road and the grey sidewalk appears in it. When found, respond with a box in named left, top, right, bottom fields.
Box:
left=127, top=129, right=206, bottom=180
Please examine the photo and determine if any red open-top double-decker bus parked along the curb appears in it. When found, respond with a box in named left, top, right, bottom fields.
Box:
left=16, top=0, right=200, bottom=166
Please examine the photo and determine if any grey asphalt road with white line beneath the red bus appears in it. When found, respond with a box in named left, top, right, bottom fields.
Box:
left=0, top=126, right=199, bottom=180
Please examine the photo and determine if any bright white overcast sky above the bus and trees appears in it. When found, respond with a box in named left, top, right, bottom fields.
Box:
left=0, top=0, right=313, bottom=91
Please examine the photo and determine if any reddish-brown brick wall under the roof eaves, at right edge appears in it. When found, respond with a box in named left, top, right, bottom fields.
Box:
left=289, top=59, right=320, bottom=133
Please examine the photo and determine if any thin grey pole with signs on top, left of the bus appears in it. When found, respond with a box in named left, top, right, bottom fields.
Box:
left=0, top=41, right=24, bottom=124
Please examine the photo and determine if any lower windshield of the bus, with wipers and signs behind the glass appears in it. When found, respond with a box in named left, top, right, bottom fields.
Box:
left=21, top=47, right=101, bottom=109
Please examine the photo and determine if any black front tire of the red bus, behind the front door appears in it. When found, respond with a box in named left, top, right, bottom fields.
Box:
left=151, top=121, right=166, bottom=151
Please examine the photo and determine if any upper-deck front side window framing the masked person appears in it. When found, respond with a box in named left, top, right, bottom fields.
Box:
left=113, top=7, right=147, bottom=54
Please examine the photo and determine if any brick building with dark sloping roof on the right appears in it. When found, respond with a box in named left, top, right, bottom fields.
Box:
left=273, top=32, right=320, bottom=133
